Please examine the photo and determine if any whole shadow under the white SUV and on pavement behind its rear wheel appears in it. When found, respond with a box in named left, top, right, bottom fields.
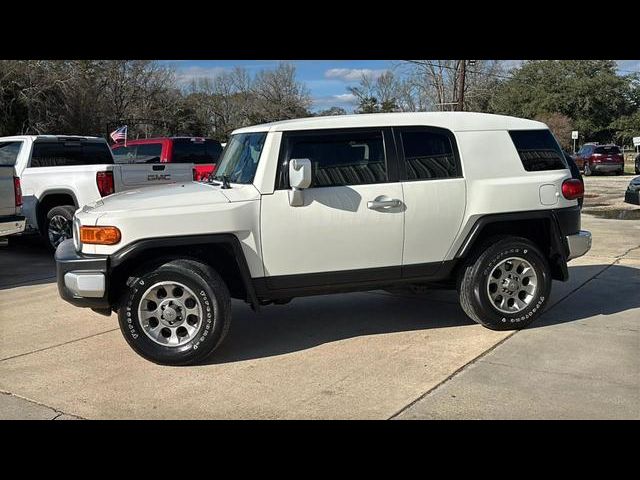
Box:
left=205, top=265, right=640, bottom=364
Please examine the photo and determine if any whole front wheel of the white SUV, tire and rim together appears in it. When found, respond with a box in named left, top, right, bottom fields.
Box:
left=118, top=259, right=231, bottom=365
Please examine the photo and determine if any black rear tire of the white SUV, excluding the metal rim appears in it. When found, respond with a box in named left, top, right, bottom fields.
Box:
left=458, top=237, right=552, bottom=330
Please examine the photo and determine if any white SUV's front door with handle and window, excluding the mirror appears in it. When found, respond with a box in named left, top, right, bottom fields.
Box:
left=261, top=128, right=404, bottom=288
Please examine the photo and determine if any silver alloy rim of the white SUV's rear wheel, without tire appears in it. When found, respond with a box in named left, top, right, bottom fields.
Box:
left=487, top=257, right=538, bottom=313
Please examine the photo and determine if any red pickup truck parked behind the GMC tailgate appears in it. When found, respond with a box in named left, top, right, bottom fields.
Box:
left=111, top=137, right=222, bottom=181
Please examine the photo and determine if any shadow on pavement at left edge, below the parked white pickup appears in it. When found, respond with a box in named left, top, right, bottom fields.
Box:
left=0, top=235, right=56, bottom=290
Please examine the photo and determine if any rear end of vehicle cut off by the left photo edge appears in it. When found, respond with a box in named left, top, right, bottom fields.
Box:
left=0, top=142, right=25, bottom=237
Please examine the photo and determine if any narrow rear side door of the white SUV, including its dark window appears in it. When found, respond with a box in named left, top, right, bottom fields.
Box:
left=394, top=127, right=466, bottom=278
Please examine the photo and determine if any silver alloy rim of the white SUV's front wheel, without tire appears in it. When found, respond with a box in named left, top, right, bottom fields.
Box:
left=138, top=282, right=204, bottom=347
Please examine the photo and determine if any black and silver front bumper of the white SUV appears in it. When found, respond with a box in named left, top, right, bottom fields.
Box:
left=55, top=239, right=110, bottom=309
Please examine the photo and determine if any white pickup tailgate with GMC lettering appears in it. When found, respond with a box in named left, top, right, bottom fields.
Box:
left=113, top=163, right=193, bottom=192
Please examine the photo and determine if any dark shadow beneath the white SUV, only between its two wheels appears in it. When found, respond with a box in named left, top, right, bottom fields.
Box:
left=204, top=292, right=474, bottom=364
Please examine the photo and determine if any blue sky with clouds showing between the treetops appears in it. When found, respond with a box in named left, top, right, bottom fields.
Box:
left=165, top=60, right=640, bottom=111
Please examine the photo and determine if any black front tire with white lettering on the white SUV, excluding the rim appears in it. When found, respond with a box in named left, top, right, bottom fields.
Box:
left=118, top=259, right=231, bottom=365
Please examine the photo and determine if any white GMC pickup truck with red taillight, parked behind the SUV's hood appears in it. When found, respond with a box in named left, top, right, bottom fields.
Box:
left=0, top=135, right=193, bottom=249
